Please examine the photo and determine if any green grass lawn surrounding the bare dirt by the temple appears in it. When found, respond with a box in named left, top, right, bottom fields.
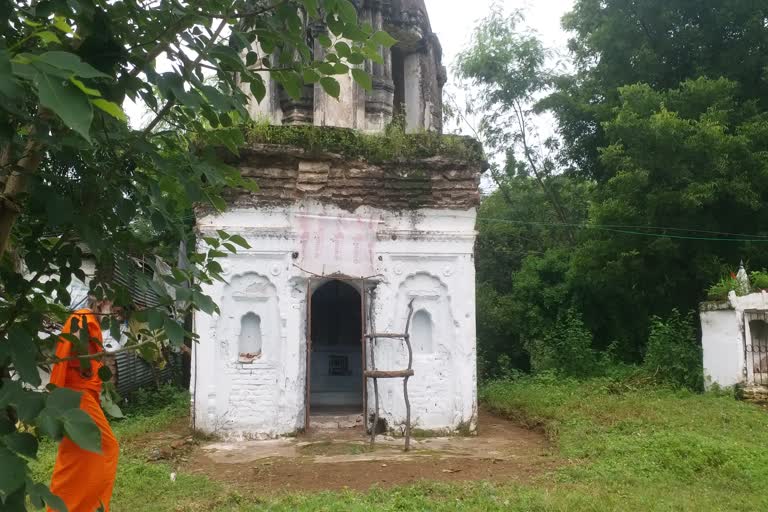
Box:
left=27, top=377, right=768, bottom=512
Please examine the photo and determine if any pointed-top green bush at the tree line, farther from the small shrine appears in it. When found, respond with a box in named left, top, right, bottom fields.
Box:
left=528, top=308, right=598, bottom=377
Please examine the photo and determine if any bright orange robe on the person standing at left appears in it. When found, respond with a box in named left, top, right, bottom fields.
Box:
left=48, top=309, right=120, bottom=512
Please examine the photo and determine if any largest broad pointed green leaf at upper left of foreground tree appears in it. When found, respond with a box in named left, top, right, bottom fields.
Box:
left=35, top=73, right=93, bottom=142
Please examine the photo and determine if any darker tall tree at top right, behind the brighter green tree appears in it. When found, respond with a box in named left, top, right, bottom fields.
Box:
left=544, top=0, right=768, bottom=179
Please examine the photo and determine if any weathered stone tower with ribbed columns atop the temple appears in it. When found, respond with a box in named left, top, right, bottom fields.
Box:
left=244, top=0, right=446, bottom=132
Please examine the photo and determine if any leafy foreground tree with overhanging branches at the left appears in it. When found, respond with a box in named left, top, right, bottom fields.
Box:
left=0, top=0, right=394, bottom=511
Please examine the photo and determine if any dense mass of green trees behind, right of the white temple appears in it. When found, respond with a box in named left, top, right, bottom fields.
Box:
left=457, top=0, right=768, bottom=387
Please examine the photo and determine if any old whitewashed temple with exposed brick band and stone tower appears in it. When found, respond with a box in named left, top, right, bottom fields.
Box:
left=191, top=0, right=484, bottom=439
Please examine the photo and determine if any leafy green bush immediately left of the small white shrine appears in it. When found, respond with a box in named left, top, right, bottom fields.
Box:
left=643, top=310, right=704, bottom=391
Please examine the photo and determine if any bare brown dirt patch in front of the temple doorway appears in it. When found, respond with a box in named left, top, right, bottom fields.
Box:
left=134, top=412, right=562, bottom=495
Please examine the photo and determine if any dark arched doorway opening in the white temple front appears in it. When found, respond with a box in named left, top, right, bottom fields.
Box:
left=308, top=280, right=363, bottom=416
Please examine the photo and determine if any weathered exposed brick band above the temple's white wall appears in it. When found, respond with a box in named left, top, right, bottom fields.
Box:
left=219, top=144, right=481, bottom=211
